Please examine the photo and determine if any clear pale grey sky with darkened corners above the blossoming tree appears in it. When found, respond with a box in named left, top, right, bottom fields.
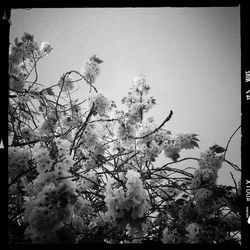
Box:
left=10, top=7, right=241, bottom=185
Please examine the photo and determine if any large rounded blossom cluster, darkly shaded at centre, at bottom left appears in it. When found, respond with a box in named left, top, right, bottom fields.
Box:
left=24, top=181, right=76, bottom=243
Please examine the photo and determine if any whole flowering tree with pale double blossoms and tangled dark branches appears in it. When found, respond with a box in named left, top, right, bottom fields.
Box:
left=8, top=33, right=241, bottom=244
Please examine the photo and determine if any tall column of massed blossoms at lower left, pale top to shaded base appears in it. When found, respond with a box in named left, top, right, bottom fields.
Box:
left=22, top=138, right=91, bottom=243
